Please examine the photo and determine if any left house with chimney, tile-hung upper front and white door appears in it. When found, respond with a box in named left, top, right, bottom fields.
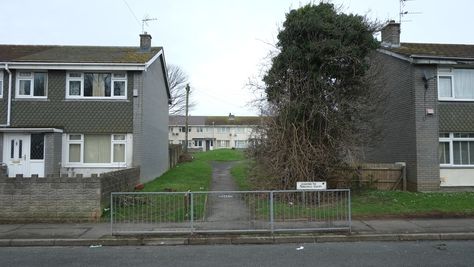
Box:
left=0, top=33, right=170, bottom=180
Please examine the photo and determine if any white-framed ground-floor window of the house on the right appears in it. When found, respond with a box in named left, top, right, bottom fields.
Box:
left=438, top=133, right=474, bottom=167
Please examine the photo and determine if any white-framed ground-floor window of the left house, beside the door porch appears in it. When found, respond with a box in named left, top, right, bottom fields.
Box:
left=66, top=134, right=127, bottom=166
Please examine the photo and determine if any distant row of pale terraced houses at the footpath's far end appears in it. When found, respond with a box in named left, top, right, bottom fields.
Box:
left=168, top=114, right=261, bottom=151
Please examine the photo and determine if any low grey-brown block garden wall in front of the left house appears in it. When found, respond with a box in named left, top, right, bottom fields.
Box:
left=0, top=168, right=140, bottom=222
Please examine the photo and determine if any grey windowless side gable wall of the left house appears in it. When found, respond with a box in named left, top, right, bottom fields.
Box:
left=133, top=56, right=169, bottom=181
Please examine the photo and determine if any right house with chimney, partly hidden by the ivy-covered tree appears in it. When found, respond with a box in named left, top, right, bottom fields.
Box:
left=366, top=21, right=474, bottom=191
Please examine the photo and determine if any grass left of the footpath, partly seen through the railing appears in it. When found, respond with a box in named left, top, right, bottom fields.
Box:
left=107, top=149, right=244, bottom=222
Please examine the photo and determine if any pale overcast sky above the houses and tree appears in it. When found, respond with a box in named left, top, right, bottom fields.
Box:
left=0, top=0, right=474, bottom=115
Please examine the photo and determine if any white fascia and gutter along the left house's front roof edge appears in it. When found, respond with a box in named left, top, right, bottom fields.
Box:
left=0, top=62, right=145, bottom=71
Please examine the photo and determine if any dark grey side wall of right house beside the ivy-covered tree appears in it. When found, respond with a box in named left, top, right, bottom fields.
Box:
left=366, top=53, right=417, bottom=190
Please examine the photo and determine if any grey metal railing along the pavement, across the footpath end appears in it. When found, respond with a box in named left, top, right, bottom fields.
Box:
left=110, top=189, right=351, bottom=234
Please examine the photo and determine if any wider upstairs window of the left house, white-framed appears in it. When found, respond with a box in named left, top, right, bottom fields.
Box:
left=66, top=72, right=127, bottom=99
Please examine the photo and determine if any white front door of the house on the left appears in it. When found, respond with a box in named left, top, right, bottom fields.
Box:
left=3, top=133, right=30, bottom=177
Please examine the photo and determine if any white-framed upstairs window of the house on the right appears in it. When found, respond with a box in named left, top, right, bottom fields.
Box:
left=438, top=68, right=474, bottom=101
